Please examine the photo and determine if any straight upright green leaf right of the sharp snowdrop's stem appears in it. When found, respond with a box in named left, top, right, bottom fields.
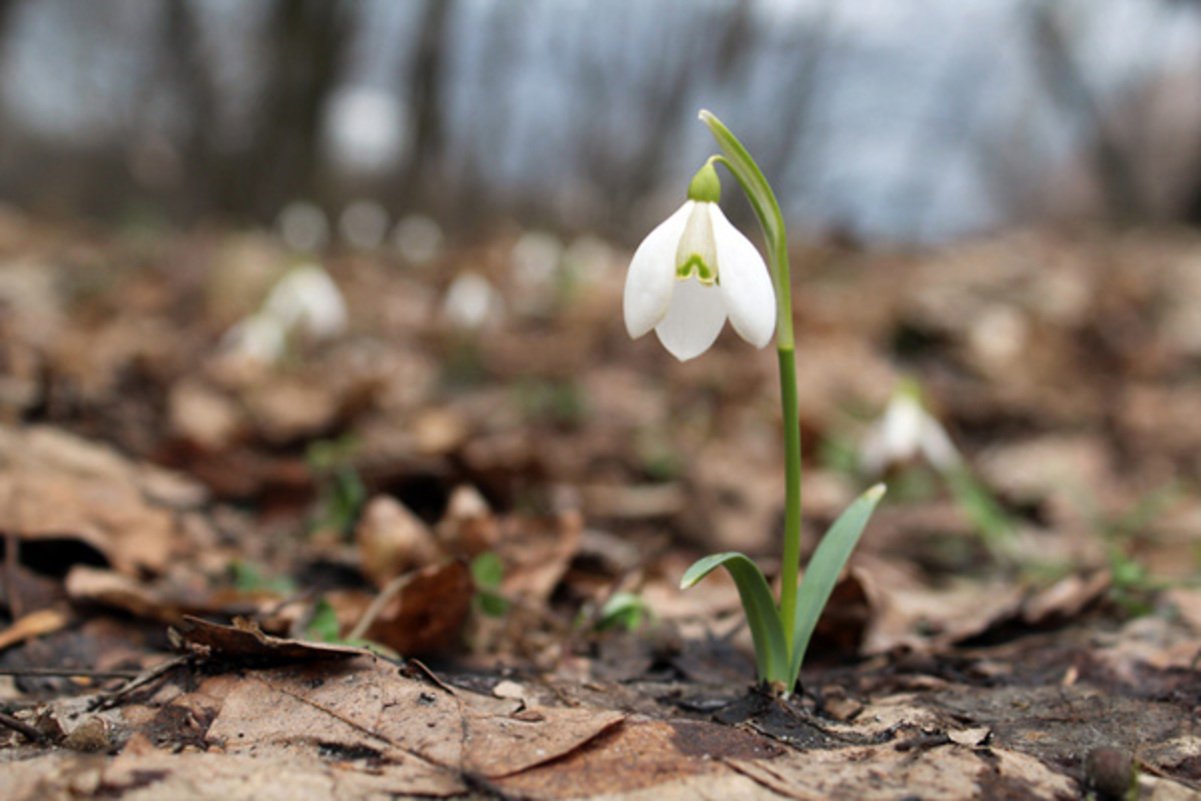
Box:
left=789, top=484, right=885, bottom=687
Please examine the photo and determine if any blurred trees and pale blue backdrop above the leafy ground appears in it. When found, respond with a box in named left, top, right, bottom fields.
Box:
left=7, top=0, right=1201, bottom=243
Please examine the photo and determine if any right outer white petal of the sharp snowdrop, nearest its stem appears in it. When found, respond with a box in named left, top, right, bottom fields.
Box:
left=710, top=203, right=776, bottom=347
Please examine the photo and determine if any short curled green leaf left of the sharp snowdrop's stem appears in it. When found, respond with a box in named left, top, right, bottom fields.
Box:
left=680, top=551, right=791, bottom=692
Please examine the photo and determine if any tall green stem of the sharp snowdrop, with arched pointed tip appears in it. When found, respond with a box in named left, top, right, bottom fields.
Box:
left=700, top=110, right=801, bottom=657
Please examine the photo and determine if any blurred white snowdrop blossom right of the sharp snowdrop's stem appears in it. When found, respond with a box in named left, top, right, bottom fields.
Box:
left=860, top=382, right=961, bottom=476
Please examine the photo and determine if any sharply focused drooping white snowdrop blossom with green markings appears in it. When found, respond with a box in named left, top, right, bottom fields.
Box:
left=623, top=163, right=776, bottom=361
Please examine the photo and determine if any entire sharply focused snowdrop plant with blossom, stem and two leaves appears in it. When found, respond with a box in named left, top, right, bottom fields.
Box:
left=623, top=110, right=884, bottom=695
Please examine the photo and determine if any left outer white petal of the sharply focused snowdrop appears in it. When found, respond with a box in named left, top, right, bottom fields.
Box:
left=622, top=201, right=695, bottom=339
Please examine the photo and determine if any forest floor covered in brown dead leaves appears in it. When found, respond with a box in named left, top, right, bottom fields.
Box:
left=0, top=216, right=1201, bottom=801
